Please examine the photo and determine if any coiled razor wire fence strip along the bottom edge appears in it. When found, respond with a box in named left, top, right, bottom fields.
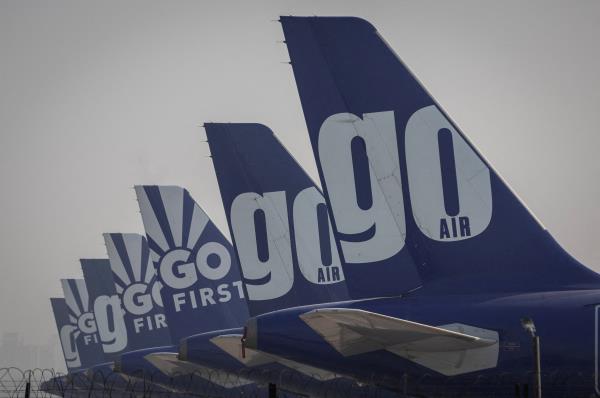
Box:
left=0, top=368, right=595, bottom=398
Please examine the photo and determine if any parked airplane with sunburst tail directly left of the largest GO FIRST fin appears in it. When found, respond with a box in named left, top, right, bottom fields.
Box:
left=104, top=233, right=256, bottom=396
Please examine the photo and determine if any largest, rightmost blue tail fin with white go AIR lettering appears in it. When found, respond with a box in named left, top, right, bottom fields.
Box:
left=281, top=17, right=598, bottom=294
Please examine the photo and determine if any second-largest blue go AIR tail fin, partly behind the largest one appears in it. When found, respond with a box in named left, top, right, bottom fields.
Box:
left=205, top=123, right=348, bottom=315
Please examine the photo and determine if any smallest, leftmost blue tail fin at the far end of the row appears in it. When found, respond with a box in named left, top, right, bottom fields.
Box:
left=50, top=297, right=82, bottom=372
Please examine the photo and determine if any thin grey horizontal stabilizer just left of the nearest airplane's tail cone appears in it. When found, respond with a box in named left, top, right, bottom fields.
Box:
left=210, top=334, right=339, bottom=381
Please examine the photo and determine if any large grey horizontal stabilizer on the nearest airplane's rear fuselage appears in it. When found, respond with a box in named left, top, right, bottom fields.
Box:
left=300, top=308, right=498, bottom=375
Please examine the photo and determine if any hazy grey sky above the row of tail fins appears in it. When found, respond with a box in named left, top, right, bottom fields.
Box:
left=0, top=0, right=600, bottom=354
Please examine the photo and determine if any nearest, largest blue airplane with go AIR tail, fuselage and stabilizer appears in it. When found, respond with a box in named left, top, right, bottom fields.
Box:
left=244, top=17, right=600, bottom=397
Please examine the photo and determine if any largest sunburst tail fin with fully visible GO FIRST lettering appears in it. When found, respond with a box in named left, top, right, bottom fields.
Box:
left=135, top=186, right=244, bottom=312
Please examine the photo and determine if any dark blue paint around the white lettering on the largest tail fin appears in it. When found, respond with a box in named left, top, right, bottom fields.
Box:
left=281, top=17, right=599, bottom=298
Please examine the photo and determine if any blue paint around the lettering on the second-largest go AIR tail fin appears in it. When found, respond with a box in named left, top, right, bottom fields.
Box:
left=204, top=123, right=348, bottom=315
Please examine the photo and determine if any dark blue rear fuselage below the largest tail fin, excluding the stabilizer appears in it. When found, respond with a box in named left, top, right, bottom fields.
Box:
left=247, top=289, right=600, bottom=397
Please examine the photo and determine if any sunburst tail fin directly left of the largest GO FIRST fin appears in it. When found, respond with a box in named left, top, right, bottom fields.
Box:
left=104, top=234, right=171, bottom=350
